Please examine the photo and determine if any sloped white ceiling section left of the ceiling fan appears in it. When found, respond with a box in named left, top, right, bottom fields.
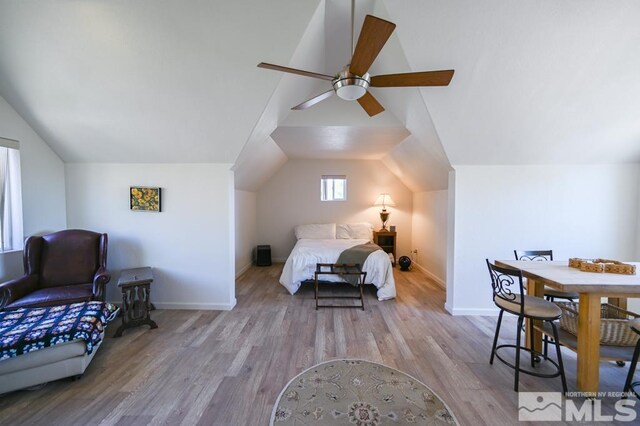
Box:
left=0, top=0, right=321, bottom=163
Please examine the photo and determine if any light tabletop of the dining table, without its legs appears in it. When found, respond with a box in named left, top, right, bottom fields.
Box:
left=496, top=260, right=640, bottom=294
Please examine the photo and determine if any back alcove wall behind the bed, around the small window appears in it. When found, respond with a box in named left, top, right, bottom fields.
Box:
left=257, top=160, right=413, bottom=261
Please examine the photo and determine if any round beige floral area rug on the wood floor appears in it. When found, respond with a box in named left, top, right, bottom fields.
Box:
left=270, top=359, right=458, bottom=426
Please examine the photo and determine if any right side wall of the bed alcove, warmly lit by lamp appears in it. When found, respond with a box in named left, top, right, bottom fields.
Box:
left=411, top=191, right=448, bottom=286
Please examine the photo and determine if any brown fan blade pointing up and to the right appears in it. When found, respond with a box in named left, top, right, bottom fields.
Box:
left=349, top=15, right=396, bottom=76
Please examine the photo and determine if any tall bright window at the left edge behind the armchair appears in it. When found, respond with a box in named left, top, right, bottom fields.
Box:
left=0, top=137, right=23, bottom=252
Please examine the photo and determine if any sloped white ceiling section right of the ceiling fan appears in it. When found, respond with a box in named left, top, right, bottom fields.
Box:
left=384, top=0, right=640, bottom=165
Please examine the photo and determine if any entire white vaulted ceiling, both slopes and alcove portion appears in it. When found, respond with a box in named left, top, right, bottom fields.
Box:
left=0, top=0, right=640, bottom=191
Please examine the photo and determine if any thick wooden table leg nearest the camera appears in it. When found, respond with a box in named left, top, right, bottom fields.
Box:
left=577, top=293, right=600, bottom=395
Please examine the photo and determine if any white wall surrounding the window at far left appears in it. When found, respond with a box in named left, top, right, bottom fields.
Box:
left=0, top=97, right=67, bottom=281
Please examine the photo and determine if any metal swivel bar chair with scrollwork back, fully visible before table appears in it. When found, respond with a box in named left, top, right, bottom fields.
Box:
left=487, top=259, right=567, bottom=393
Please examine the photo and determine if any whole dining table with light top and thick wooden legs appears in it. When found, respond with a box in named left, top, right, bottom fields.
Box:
left=495, top=260, right=640, bottom=396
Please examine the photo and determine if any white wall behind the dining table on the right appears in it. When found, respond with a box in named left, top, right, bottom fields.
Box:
left=446, top=165, right=639, bottom=315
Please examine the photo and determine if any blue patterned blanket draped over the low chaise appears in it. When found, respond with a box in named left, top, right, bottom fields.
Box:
left=0, top=302, right=118, bottom=361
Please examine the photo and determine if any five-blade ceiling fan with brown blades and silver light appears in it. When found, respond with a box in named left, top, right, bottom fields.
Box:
left=258, top=0, right=454, bottom=117
